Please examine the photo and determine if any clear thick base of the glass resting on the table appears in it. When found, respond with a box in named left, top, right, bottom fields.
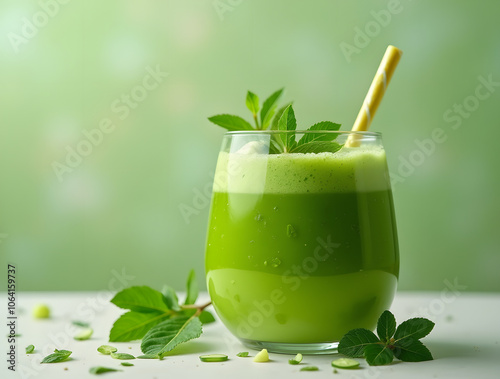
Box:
left=239, top=338, right=339, bottom=354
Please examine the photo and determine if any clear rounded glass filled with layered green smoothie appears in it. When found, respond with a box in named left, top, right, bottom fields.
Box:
left=205, top=131, right=399, bottom=354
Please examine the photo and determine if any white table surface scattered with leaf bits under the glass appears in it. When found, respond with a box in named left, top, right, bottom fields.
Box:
left=0, top=290, right=500, bottom=379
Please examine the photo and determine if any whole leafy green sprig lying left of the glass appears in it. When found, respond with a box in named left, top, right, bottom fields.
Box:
left=109, top=270, right=215, bottom=358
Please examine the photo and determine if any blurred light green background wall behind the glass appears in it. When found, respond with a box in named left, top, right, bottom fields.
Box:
left=0, top=0, right=500, bottom=291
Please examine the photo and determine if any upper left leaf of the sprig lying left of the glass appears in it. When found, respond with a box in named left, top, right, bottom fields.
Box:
left=111, top=286, right=169, bottom=312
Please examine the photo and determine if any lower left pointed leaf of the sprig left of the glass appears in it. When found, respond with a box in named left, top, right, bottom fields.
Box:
left=109, top=311, right=169, bottom=342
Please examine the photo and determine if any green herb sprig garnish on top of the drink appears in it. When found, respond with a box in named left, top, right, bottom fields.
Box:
left=208, top=89, right=343, bottom=154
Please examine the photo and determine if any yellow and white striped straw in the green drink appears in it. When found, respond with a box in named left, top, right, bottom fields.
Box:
left=346, top=45, right=403, bottom=147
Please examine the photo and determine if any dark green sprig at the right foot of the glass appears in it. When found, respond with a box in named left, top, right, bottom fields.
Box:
left=338, top=311, right=434, bottom=366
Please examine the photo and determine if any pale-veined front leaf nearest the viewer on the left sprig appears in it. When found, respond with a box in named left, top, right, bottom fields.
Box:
left=141, top=315, right=202, bottom=358
